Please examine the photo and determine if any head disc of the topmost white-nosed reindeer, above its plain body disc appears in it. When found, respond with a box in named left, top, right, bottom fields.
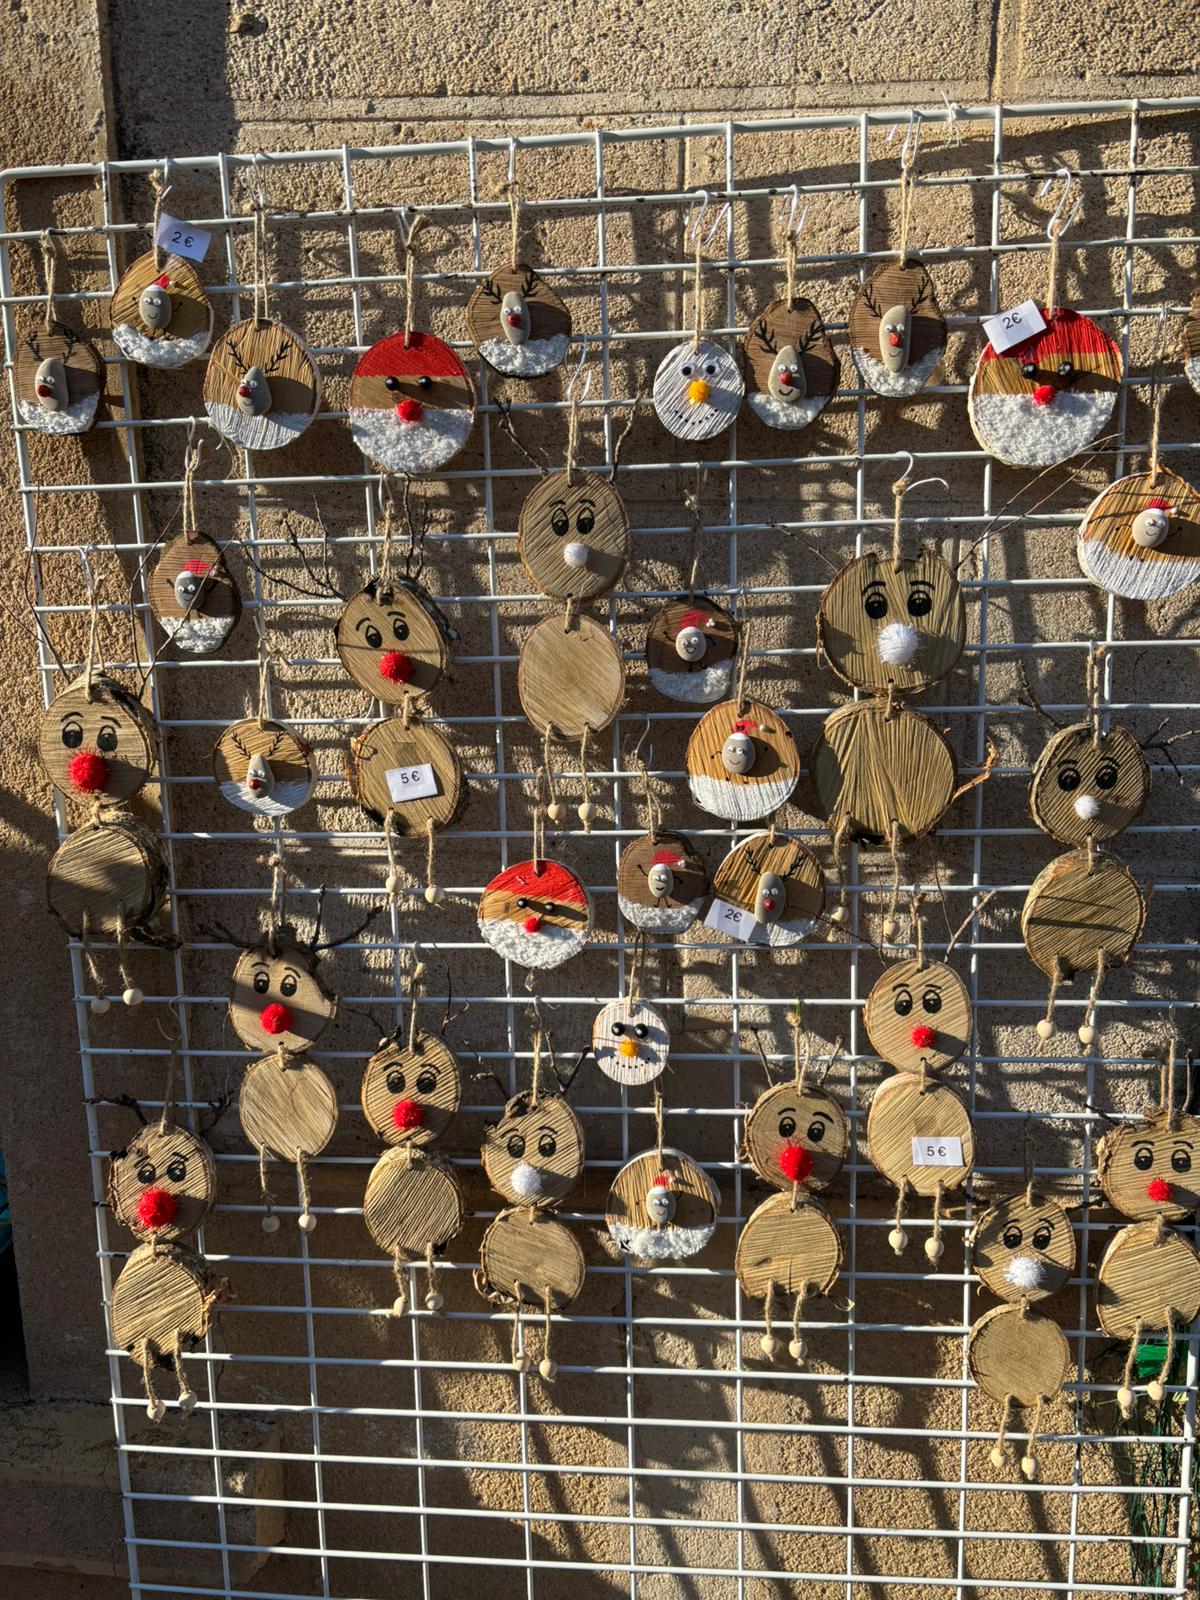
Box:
left=517, top=472, right=629, bottom=600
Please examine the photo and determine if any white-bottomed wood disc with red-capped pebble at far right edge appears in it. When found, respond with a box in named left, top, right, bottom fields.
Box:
left=1075, top=473, right=1200, bottom=600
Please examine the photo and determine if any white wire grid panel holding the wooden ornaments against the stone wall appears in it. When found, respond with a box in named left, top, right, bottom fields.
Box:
left=0, top=99, right=1200, bottom=1600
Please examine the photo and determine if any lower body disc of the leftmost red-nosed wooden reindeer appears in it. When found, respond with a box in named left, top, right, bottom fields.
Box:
left=46, top=816, right=166, bottom=939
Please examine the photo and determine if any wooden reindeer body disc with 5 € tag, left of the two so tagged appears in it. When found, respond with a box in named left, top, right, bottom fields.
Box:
left=350, top=717, right=467, bottom=838
